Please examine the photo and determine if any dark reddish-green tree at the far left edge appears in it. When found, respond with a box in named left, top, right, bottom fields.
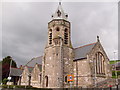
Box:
left=2, top=56, right=17, bottom=79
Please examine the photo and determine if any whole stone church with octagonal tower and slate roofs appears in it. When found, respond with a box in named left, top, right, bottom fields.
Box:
left=18, top=3, right=112, bottom=88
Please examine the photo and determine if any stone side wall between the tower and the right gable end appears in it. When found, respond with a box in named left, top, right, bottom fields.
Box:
left=74, top=59, right=91, bottom=87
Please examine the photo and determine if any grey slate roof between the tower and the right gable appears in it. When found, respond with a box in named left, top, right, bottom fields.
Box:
left=74, top=43, right=96, bottom=60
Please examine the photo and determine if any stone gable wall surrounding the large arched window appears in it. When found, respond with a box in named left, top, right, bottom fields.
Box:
left=88, top=42, right=112, bottom=84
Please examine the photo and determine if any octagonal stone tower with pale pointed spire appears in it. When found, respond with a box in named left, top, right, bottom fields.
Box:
left=42, top=3, right=73, bottom=88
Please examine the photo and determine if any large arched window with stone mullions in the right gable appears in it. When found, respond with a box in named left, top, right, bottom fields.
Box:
left=95, top=52, right=105, bottom=74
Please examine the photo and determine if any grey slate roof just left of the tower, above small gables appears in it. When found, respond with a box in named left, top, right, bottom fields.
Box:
left=26, top=56, right=42, bottom=67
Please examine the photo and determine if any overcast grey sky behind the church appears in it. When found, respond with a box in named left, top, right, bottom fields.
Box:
left=0, top=2, right=118, bottom=66
